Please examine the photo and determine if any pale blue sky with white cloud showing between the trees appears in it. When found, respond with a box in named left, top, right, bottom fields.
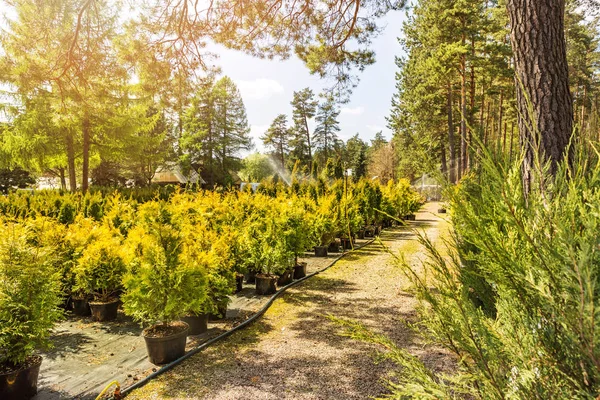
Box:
left=206, top=11, right=406, bottom=152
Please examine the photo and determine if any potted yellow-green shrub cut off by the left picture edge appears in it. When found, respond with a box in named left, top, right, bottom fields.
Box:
left=0, top=222, right=62, bottom=400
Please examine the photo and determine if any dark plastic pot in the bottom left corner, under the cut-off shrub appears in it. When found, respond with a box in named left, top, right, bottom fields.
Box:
left=0, top=356, right=42, bottom=400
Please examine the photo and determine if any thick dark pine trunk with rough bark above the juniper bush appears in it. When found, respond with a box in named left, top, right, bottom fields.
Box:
left=506, top=0, right=573, bottom=193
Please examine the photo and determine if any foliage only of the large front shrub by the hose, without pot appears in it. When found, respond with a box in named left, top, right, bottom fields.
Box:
left=122, top=202, right=207, bottom=324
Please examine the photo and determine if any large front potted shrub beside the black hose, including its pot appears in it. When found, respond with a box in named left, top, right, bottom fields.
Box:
left=122, top=202, right=207, bottom=364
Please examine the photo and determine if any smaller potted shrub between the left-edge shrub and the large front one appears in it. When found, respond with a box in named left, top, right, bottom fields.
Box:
left=74, top=226, right=125, bottom=321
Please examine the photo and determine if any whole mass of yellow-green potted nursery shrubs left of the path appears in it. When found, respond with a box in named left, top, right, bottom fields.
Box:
left=0, top=180, right=423, bottom=399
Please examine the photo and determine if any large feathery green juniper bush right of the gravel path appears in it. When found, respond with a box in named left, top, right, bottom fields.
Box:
left=358, top=147, right=600, bottom=399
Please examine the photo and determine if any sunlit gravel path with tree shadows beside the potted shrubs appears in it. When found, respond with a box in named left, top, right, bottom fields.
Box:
left=127, top=203, right=450, bottom=400
